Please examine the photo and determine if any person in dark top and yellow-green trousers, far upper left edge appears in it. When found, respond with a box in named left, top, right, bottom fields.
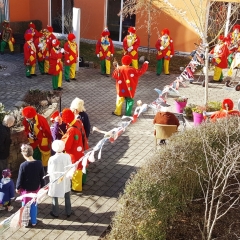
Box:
left=0, top=20, right=15, bottom=54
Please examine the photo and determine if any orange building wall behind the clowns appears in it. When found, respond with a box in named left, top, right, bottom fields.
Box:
left=9, top=0, right=199, bottom=52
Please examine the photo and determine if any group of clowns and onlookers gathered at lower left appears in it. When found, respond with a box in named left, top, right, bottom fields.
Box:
left=0, top=98, right=90, bottom=226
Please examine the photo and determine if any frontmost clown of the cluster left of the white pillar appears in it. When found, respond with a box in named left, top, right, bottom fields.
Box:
left=48, top=39, right=64, bottom=90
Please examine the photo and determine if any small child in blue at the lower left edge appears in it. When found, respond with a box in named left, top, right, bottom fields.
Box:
left=0, top=169, right=15, bottom=212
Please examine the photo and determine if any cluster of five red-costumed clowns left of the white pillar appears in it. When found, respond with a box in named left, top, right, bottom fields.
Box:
left=24, top=23, right=78, bottom=90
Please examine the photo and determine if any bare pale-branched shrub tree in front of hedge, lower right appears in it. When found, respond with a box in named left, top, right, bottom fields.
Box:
left=189, top=118, right=240, bottom=240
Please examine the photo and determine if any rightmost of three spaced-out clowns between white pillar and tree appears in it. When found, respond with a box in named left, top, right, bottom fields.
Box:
left=155, top=28, right=174, bottom=76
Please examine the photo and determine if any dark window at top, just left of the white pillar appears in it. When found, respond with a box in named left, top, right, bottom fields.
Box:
left=51, top=0, right=73, bottom=34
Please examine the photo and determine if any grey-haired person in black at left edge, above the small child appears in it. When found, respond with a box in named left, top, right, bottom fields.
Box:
left=0, top=115, right=15, bottom=173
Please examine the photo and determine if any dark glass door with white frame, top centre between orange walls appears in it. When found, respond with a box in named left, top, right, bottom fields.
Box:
left=107, top=0, right=136, bottom=43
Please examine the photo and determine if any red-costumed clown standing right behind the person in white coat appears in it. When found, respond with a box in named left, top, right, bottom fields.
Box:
left=61, top=108, right=89, bottom=191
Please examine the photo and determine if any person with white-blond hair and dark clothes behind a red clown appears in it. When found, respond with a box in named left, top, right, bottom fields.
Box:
left=70, top=97, right=91, bottom=138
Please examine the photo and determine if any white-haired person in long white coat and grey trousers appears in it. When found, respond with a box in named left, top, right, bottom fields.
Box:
left=48, top=140, right=72, bottom=218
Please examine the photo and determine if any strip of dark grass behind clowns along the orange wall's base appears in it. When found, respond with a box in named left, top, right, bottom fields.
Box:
left=80, top=42, right=190, bottom=74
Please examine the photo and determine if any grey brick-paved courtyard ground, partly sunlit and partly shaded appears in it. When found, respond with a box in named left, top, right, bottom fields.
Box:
left=0, top=54, right=240, bottom=240
